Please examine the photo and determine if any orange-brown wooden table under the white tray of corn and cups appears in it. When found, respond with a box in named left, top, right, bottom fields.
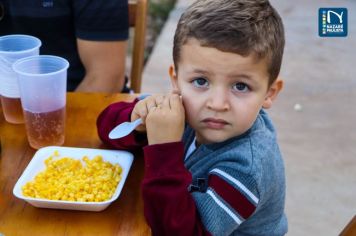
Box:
left=0, top=93, right=150, bottom=236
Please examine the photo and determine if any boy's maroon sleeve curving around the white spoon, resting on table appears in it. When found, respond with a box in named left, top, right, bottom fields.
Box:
left=96, top=99, right=147, bottom=151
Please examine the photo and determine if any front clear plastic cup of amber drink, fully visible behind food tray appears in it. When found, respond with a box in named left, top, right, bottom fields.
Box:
left=12, top=55, right=69, bottom=149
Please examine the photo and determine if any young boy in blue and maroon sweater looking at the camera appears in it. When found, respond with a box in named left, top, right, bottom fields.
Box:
left=97, top=0, right=287, bottom=236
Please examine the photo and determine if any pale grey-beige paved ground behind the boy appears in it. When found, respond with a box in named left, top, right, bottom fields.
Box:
left=143, top=0, right=356, bottom=236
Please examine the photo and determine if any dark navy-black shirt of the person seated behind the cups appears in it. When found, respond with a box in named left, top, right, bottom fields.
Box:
left=0, top=0, right=128, bottom=91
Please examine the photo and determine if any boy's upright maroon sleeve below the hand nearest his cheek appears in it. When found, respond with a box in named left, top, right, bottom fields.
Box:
left=142, top=142, right=210, bottom=236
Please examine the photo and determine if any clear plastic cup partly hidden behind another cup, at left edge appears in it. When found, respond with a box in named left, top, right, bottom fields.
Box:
left=0, top=34, right=41, bottom=124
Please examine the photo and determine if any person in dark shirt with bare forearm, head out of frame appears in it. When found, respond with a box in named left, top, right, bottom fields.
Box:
left=0, top=0, right=129, bottom=93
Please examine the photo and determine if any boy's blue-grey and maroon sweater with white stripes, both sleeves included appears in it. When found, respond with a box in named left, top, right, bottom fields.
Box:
left=97, top=102, right=287, bottom=236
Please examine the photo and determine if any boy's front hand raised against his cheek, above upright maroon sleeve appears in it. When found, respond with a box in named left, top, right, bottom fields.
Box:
left=146, top=94, right=185, bottom=145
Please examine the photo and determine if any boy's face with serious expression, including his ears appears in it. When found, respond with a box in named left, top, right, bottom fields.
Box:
left=170, top=39, right=283, bottom=144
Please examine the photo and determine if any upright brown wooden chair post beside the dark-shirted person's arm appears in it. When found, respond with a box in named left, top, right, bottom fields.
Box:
left=129, top=0, right=147, bottom=93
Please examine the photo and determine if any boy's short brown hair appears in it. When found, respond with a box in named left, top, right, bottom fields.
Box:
left=173, top=0, right=285, bottom=85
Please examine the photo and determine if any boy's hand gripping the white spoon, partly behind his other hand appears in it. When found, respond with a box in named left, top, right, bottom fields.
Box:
left=131, top=94, right=164, bottom=132
